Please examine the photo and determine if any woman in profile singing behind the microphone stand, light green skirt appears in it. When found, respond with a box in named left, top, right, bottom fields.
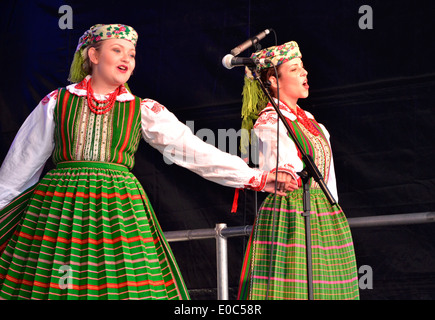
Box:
left=239, top=41, right=359, bottom=299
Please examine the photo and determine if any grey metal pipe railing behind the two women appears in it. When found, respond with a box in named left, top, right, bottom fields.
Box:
left=164, top=212, right=435, bottom=300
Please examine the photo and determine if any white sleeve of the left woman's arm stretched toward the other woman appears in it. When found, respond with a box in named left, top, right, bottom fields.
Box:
left=141, top=99, right=267, bottom=191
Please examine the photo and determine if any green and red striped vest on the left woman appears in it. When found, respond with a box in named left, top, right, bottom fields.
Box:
left=53, top=88, right=141, bottom=170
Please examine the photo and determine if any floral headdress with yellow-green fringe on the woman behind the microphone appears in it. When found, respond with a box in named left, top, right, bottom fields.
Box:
left=240, top=41, right=302, bottom=155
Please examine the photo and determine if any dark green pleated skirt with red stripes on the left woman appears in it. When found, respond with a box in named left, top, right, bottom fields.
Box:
left=0, top=162, right=189, bottom=300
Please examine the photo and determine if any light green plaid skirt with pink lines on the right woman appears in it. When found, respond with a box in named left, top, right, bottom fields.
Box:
left=239, top=189, right=359, bottom=300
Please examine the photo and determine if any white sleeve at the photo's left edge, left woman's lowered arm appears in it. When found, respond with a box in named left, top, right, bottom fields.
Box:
left=0, top=91, right=57, bottom=208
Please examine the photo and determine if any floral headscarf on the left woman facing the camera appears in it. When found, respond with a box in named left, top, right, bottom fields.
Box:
left=68, top=24, right=138, bottom=83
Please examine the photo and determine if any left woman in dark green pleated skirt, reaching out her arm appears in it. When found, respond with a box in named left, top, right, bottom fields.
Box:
left=0, top=24, right=297, bottom=299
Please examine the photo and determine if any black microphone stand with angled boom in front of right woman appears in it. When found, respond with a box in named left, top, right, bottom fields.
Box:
left=248, top=65, right=337, bottom=300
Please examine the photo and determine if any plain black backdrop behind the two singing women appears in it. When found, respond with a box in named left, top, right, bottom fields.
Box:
left=0, top=0, right=435, bottom=299
